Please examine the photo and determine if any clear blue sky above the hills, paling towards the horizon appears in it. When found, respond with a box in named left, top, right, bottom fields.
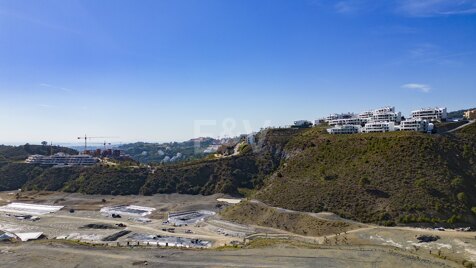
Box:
left=0, top=0, right=476, bottom=143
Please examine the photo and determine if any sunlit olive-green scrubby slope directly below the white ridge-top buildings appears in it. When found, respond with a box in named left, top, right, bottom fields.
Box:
left=256, top=124, right=476, bottom=225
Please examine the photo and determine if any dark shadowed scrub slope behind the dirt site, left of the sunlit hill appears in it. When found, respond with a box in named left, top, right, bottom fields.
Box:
left=0, top=129, right=300, bottom=195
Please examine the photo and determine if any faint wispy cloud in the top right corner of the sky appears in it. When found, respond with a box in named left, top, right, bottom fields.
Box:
left=397, top=0, right=476, bottom=17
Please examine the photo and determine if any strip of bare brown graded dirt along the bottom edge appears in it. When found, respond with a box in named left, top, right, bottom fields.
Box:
left=0, top=243, right=457, bottom=267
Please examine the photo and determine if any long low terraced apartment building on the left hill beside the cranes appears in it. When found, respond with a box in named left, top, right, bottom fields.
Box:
left=25, top=153, right=98, bottom=167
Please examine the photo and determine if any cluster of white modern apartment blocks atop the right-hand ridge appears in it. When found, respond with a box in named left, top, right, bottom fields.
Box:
left=326, top=106, right=447, bottom=134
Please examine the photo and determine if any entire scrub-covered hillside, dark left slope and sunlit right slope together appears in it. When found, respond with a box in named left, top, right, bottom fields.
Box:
left=0, top=124, right=476, bottom=226
